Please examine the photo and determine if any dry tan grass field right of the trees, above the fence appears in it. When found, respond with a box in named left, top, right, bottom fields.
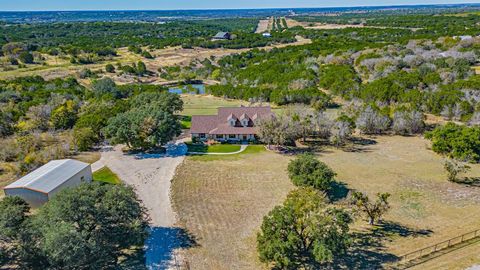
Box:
left=320, top=136, right=480, bottom=269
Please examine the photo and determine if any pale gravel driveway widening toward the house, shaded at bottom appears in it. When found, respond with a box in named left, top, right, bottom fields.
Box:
left=92, top=146, right=184, bottom=269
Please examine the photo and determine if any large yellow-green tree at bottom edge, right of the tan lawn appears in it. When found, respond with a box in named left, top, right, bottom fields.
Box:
left=257, top=187, right=352, bottom=269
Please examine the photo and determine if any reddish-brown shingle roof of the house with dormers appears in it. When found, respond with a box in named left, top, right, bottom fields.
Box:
left=190, top=107, right=273, bottom=135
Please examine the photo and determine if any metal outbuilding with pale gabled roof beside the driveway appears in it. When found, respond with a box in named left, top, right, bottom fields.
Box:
left=4, top=159, right=92, bottom=207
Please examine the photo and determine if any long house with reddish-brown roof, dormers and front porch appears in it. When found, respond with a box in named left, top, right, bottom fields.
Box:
left=190, top=107, right=274, bottom=142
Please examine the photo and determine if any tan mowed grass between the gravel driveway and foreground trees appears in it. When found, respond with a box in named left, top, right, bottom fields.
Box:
left=172, top=151, right=293, bottom=269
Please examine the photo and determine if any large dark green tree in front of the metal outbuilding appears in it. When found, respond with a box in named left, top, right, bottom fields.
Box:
left=25, top=183, right=147, bottom=269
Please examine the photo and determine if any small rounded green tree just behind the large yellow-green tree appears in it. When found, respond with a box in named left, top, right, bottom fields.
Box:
left=288, top=154, right=336, bottom=191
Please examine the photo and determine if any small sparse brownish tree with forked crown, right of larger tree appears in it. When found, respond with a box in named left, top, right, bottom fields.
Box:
left=352, top=192, right=390, bottom=225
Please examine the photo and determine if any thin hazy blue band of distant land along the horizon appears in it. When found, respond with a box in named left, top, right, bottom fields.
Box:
left=0, top=3, right=480, bottom=12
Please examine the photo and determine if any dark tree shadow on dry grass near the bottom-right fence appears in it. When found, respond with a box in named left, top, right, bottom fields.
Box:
left=332, top=222, right=433, bottom=269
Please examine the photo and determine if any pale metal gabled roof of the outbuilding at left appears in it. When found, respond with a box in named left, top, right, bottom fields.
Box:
left=4, top=159, right=90, bottom=193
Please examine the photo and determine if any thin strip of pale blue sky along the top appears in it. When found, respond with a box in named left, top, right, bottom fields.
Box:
left=0, top=0, right=475, bottom=11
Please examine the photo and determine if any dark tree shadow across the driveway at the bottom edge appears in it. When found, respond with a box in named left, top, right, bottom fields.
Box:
left=124, top=227, right=198, bottom=270
